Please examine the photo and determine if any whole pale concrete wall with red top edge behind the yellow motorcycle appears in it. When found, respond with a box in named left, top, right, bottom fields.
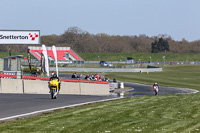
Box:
left=0, top=75, right=109, bottom=95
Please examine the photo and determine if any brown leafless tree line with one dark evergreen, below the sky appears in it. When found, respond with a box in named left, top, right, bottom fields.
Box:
left=0, top=27, right=200, bottom=53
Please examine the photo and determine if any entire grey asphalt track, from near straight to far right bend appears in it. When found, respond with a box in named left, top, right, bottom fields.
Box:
left=0, top=72, right=198, bottom=121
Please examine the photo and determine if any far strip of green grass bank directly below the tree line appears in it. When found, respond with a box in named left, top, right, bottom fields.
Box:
left=78, top=53, right=200, bottom=62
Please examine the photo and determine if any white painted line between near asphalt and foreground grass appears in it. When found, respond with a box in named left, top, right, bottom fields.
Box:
left=0, top=97, right=122, bottom=121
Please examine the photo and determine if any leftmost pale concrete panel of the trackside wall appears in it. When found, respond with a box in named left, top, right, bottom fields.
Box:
left=1, top=78, right=23, bottom=93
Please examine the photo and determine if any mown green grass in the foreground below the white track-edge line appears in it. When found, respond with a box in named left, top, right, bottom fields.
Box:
left=0, top=94, right=200, bottom=133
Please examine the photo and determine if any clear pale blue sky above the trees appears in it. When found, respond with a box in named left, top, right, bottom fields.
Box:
left=0, top=0, right=200, bottom=42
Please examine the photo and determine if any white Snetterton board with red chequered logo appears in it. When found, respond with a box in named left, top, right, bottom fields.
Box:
left=0, top=30, right=40, bottom=44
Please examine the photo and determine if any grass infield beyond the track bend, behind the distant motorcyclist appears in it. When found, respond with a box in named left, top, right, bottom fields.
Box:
left=107, top=65, right=200, bottom=90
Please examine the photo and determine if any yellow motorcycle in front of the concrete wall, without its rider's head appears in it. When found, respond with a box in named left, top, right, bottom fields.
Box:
left=49, top=79, right=60, bottom=99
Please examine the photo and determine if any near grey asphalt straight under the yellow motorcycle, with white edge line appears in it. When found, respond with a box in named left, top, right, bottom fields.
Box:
left=0, top=94, right=116, bottom=121
